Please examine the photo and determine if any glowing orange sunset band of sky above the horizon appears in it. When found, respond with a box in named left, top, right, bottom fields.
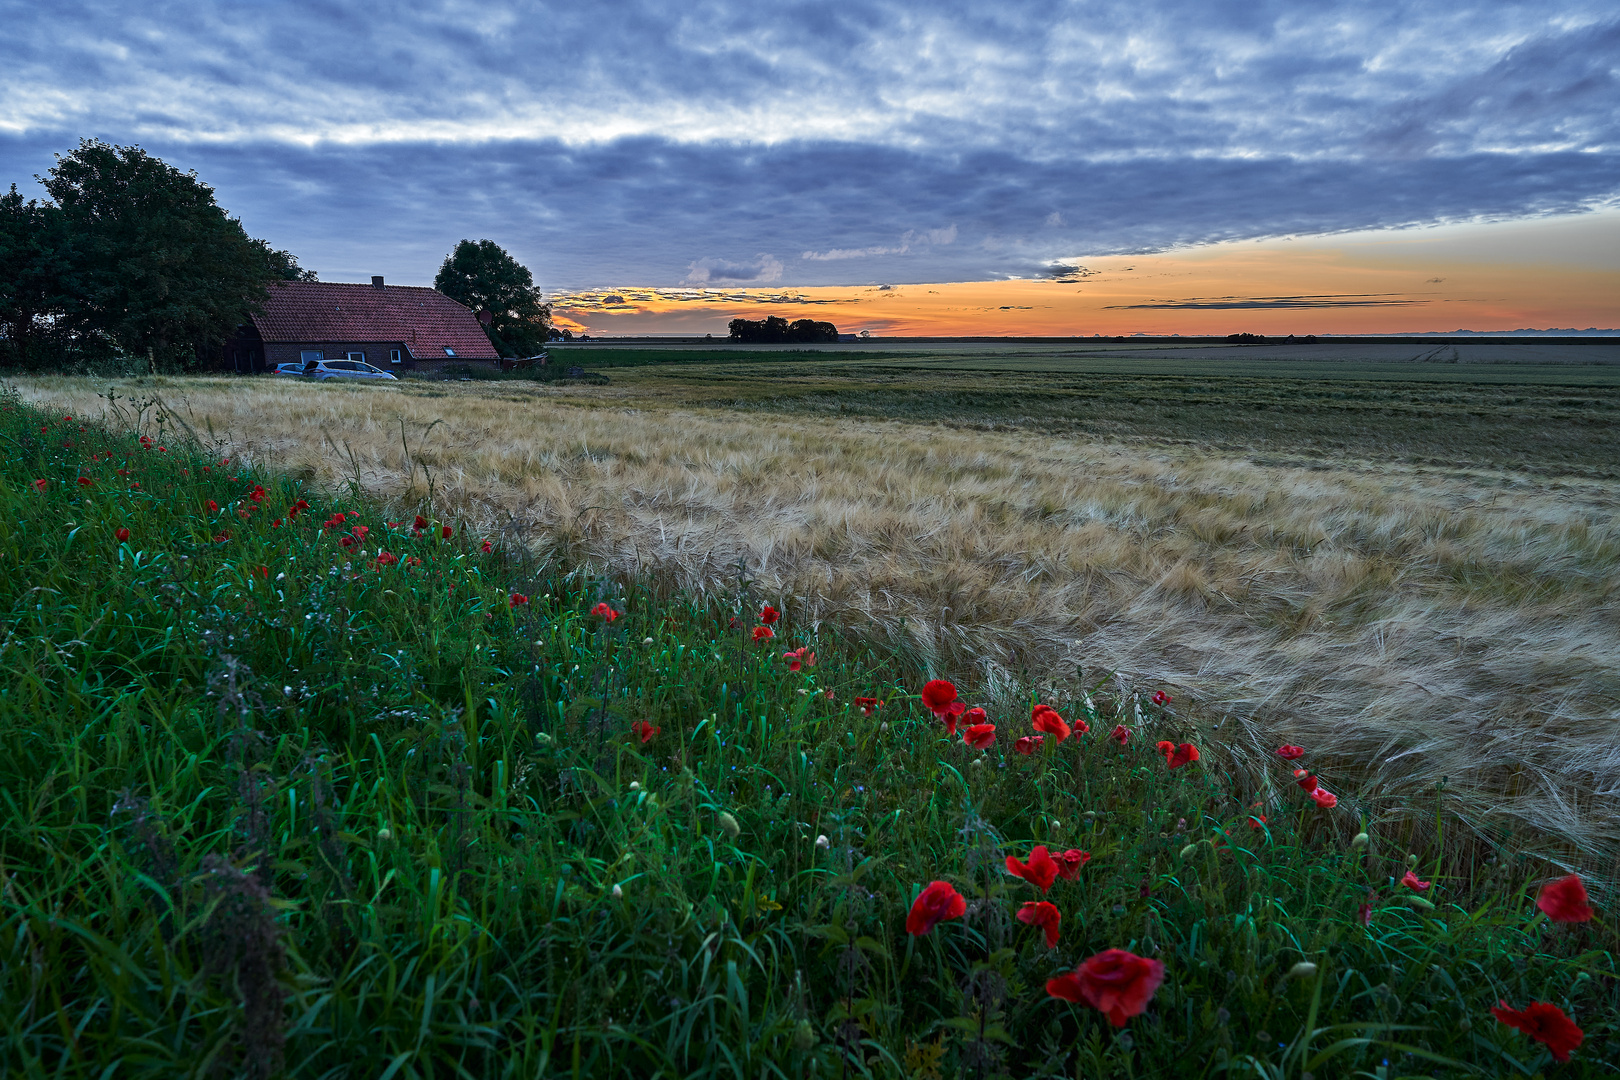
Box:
left=551, top=210, right=1620, bottom=337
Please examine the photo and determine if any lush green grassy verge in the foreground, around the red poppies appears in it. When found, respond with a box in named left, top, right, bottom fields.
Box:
left=0, top=398, right=1620, bottom=1077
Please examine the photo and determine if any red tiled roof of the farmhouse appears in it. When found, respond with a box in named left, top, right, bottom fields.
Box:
left=253, top=282, right=499, bottom=359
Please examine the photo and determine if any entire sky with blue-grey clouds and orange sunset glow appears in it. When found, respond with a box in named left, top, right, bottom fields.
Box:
left=0, top=0, right=1620, bottom=335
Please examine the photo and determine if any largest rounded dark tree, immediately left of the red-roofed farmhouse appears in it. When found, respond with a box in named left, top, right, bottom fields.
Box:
left=41, top=139, right=285, bottom=363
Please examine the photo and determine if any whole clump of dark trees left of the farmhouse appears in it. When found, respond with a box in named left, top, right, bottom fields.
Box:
left=0, top=139, right=314, bottom=368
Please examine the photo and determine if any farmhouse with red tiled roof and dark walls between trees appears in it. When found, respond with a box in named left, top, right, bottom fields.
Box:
left=224, top=277, right=501, bottom=374
